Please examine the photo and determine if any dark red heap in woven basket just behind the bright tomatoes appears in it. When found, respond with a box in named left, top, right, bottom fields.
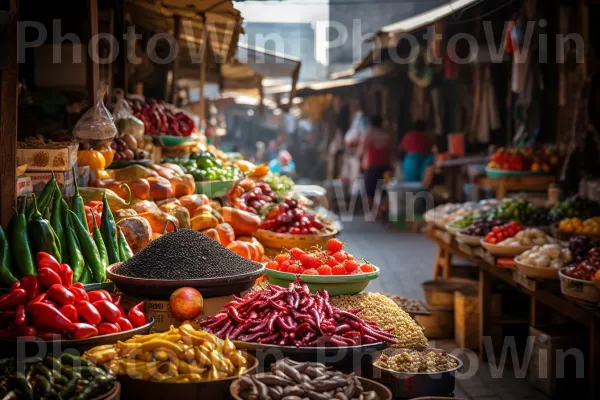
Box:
left=261, top=198, right=323, bottom=235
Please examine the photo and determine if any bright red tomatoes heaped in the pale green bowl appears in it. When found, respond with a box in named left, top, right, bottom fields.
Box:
left=266, top=239, right=375, bottom=275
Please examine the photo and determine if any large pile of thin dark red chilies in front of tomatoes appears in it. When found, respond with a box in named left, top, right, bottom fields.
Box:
left=200, top=281, right=396, bottom=347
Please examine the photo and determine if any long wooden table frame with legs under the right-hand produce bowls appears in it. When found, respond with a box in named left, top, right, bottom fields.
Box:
left=427, top=227, right=600, bottom=399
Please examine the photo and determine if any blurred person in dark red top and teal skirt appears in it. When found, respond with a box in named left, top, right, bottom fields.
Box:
left=399, top=120, right=433, bottom=182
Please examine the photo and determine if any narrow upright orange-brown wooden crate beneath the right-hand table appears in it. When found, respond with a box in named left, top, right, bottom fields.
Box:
left=454, top=291, right=479, bottom=350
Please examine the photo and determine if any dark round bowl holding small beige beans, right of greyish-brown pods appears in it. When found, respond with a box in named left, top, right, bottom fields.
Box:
left=372, top=349, right=463, bottom=399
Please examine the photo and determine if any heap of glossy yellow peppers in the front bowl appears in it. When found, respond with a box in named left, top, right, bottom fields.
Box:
left=83, top=321, right=249, bottom=383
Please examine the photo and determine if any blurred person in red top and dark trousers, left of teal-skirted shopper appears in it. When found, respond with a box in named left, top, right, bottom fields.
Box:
left=360, top=115, right=393, bottom=204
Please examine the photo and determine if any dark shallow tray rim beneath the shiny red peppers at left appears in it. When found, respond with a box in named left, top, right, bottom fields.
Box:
left=0, top=316, right=154, bottom=357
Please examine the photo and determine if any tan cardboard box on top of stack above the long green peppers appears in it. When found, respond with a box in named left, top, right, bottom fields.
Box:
left=17, top=143, right=79, bottom=171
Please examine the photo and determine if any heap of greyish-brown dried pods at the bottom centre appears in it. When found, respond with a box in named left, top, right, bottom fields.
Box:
left=234, top=358, right=379, bottom=400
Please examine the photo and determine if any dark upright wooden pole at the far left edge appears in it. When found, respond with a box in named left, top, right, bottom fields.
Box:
left=0, top=0, right=19, bottom=228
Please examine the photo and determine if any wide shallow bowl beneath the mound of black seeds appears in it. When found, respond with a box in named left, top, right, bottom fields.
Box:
left=106, top=263, right=265, bottom=298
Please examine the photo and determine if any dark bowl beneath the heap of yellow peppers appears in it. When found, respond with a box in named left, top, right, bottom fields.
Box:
left=117, top=354, right=258, bottom=400
